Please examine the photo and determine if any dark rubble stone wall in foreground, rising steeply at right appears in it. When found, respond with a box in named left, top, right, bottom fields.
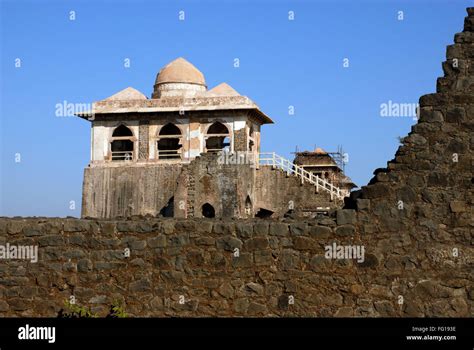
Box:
left=0, top=8, right=474, bottom=317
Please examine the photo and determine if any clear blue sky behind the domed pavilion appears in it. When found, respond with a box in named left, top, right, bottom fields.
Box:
left=0, top=0, right=473, bottom=216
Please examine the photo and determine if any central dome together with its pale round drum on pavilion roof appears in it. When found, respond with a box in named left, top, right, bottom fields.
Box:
left=152, top=57, right=207, bottom=98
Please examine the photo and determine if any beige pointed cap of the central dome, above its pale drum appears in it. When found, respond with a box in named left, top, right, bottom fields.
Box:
left=155, top=57, right=206, bottom=86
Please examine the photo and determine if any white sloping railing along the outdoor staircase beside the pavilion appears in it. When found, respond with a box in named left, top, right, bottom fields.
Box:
left=257, top=152, right=345, bottom=200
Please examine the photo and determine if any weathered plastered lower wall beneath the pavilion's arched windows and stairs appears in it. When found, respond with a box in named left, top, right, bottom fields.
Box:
left=82, top=153, right=336, bottom=219
